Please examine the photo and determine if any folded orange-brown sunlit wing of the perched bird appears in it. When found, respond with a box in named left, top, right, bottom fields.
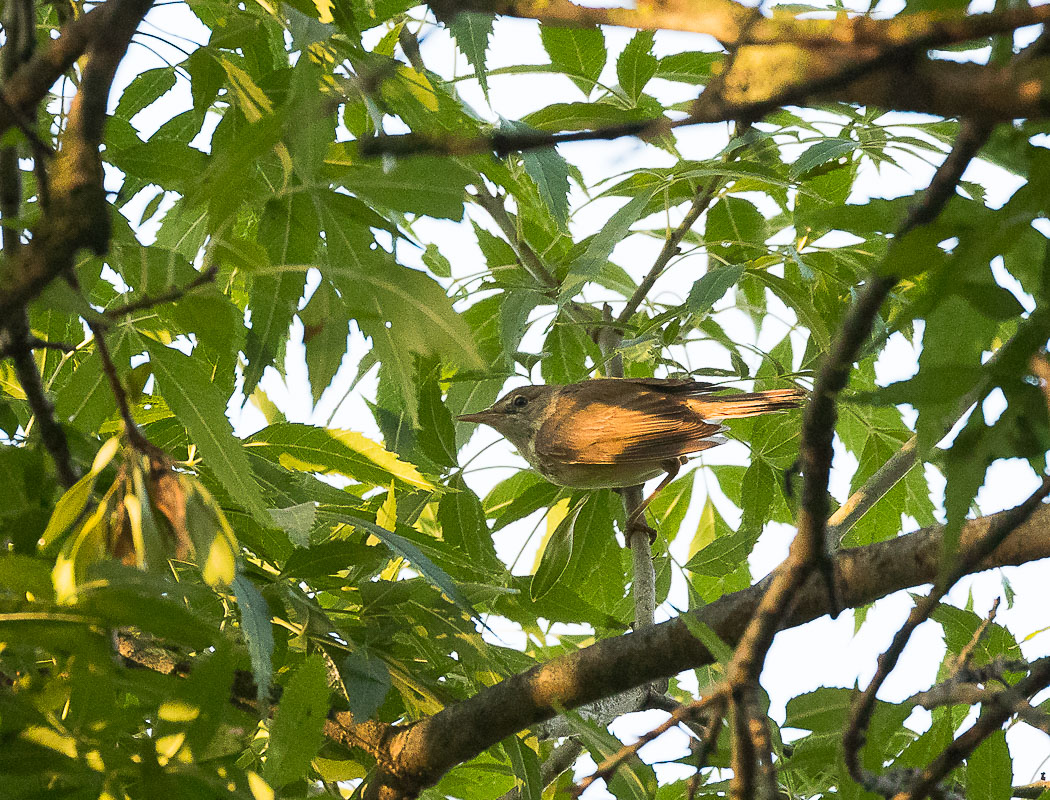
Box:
left=537, top=386, right=723, bottom=464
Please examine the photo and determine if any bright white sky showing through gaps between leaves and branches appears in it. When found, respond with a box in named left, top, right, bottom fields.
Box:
left=122, top=5, right=1048, bottom=800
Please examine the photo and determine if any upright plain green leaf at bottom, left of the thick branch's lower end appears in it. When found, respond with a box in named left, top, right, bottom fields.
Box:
left=263, top=654, right=331, bottom=786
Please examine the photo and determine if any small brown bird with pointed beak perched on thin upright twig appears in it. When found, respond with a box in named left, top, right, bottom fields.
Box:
left=459, top=378, right=805, bottom=532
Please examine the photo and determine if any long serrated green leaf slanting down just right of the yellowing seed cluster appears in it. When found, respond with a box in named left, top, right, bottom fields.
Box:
left=143, top=339, right=273, bottom=527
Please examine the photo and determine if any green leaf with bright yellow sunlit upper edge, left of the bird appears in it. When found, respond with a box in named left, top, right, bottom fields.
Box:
left=245, top=422, right=435, bottom=489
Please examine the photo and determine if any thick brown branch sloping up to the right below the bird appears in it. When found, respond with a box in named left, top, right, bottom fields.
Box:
left=366, top=506, right=1050, bottom=800
